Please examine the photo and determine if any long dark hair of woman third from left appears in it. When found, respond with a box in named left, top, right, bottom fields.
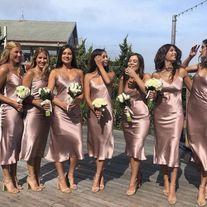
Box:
left=56, top=44, right=77, bottom=68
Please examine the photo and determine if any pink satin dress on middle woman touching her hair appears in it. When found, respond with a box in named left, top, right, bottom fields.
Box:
left=87, top=75, right=114, bottom=160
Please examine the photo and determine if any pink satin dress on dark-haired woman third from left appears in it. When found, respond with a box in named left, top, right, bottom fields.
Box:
left=45, top=75, right=83, bottom=162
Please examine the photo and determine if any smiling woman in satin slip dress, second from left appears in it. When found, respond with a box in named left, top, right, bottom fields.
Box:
left=20, top=47, right=50, bottom=191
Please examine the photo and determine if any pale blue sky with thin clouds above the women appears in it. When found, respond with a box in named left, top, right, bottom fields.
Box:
left=0, top=0, right=207, bottom=72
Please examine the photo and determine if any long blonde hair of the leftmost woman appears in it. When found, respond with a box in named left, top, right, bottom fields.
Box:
left=0, top=41, right=21, bottom=65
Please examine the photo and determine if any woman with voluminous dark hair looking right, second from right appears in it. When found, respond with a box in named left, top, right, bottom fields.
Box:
left=153, top=44, right=191, bottom=204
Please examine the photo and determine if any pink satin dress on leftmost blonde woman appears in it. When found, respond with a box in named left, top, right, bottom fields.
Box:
left=0, top=72, right=23, bottom=165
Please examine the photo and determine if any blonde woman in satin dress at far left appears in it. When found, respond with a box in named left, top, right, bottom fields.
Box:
left=0, top=41, right=23, bottom=193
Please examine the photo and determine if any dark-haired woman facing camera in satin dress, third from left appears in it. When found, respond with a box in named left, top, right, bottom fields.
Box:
left=46, top=45, right=83, bottom=193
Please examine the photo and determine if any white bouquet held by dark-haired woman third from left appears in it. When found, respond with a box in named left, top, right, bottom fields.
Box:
left=66, top=82, right=82, bottom=107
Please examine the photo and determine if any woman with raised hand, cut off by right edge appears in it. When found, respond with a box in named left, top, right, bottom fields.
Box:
left=184, top=39, right=207, bottom=206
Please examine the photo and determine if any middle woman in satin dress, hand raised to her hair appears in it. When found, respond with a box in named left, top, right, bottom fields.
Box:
left=84, top=49, right=115, bottom=193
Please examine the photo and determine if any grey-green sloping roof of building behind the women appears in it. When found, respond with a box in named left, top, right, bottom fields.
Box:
left=0, top=20, right=77, bottom=42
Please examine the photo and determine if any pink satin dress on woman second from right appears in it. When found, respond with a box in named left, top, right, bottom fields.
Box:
left=154, top=76, right=184, bottom=167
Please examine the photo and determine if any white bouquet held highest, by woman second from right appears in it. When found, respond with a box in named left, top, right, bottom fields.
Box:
left=145, top=78, right=163, bottom=111
